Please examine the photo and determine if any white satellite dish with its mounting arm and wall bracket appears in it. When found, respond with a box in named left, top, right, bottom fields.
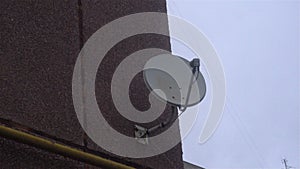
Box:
left=135, top=54, right=206, bottom=144
